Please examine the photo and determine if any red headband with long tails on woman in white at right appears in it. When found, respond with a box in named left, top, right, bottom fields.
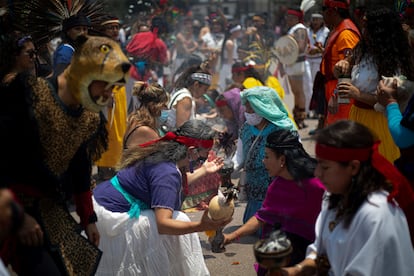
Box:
left=315, top=141, right=414, bottom=209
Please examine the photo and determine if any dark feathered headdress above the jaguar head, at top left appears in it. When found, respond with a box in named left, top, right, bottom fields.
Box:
left=10, top=0, right=104, bottom=44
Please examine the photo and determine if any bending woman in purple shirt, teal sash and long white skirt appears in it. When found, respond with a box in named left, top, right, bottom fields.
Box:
left=93, top=120, right=229, bottom=276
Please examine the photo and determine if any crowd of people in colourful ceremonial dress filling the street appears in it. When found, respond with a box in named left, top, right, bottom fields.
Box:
left=0, top=0, right=414, bottom=276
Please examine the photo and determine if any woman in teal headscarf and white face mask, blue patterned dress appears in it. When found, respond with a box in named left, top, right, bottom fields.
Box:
left=233, top=86, right=296, bottom=223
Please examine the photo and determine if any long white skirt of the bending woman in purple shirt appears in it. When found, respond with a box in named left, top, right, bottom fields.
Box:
left=93, top=199, right=210, bottom=276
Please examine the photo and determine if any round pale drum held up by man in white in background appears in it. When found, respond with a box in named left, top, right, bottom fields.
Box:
left=272, top=35, right=299, bottom=65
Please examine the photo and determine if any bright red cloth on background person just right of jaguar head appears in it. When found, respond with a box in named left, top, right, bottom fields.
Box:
left=126, top=32, right=168, bottom=64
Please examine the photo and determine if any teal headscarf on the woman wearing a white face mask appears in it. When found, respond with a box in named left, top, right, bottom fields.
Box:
left=240, top=86, right=296, bottom=130
